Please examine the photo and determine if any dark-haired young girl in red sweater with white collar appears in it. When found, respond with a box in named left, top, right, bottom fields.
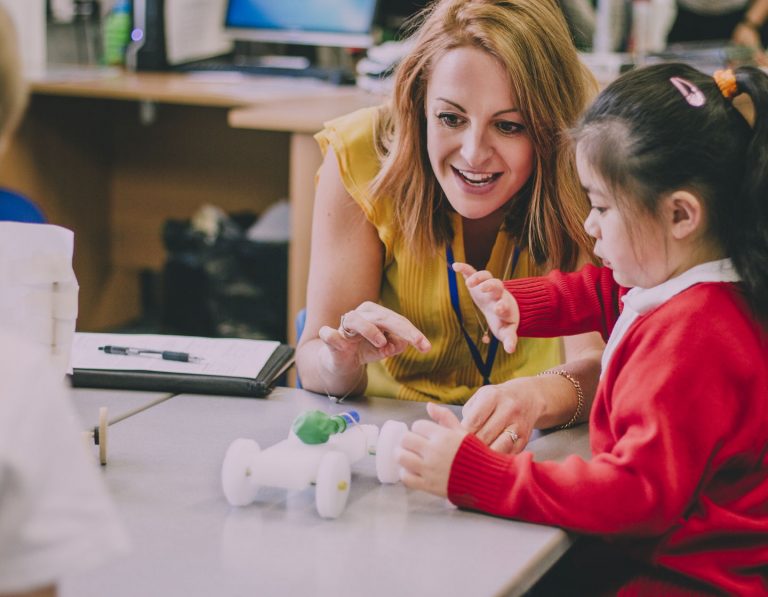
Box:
left=400, top=64, right=768, bottom=595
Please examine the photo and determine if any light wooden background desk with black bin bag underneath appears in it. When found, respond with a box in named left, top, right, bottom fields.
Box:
left=0, top=68, right=381, bottom=333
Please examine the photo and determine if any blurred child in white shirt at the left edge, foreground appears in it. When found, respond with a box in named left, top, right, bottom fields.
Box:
left=0, top=3, right=129, bottom=597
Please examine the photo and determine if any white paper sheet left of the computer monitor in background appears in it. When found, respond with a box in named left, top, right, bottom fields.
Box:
left=164, top=0, right=232, bottom=65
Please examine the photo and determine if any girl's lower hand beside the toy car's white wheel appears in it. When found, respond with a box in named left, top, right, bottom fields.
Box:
left=397, top=402, right=467, bottom=497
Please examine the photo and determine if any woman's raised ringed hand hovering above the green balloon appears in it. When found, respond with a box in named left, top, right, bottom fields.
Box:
left=318, top=301, right=432, bottom=370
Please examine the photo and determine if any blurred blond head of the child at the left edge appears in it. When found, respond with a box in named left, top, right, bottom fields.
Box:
left=0, top=6, right=27, bottom=151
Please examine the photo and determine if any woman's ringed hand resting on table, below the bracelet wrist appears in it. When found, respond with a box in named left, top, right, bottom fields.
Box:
left=461, top=377, right=546, bottom=454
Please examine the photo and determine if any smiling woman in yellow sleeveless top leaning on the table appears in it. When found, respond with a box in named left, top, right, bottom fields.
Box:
left=297, top=0, right=601, bottom=451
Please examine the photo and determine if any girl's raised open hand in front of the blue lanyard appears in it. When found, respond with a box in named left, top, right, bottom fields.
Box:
left=453, top=262, right=520, bottom=353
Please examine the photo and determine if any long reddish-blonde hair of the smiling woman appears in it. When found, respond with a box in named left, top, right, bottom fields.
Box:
left=371, top=0, right=596, bottom=270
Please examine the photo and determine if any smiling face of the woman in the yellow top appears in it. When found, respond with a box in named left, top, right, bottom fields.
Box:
left=425, top=47, right=535, bottom=219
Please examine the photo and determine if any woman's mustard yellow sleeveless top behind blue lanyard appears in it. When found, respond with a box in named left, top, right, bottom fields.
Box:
left=315, top=108, right=561, bottom=404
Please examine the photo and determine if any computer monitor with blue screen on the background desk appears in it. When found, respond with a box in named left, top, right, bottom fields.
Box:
left=224, top=0, right=377, bottom=48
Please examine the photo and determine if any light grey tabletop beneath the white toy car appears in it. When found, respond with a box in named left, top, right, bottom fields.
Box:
left=66, top=388, right=589, bottom=597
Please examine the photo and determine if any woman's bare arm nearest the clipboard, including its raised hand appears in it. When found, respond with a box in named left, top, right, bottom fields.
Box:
left=296, top=148, right=431, bottom=396
